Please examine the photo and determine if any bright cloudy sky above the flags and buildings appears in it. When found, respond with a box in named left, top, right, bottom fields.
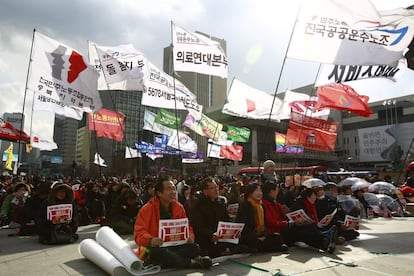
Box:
left=0, top=0, right=414, bottom=138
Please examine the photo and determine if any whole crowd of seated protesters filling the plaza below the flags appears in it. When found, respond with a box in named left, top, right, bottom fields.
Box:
left=0, top=160, right=414, bottom=268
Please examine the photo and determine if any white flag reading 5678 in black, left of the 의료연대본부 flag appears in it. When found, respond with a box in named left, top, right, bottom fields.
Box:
left=141, top=61, right=202, bottom=112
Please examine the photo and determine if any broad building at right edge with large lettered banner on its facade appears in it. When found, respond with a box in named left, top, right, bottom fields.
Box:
left=338, top=95, right=414, bottom=174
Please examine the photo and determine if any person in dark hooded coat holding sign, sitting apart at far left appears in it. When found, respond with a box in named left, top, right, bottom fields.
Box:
left=35, top=181, right=79, bottom=244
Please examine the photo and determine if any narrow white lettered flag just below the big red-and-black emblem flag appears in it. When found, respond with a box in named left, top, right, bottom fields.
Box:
left=33, top=93, right=83, bottom=120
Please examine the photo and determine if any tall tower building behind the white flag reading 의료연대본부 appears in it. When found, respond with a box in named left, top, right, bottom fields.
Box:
left=164, top=31, right=227, bottom=155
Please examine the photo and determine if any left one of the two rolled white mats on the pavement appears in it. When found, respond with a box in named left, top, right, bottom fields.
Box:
left=79, top=239, right=131, bottom=276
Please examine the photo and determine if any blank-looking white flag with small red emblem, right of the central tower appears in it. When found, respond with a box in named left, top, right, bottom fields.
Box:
left=222, top=78, right=282, bottom=122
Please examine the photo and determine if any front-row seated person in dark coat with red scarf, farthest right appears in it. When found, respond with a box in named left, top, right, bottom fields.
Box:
left=285, top=188, right=337, bottom=253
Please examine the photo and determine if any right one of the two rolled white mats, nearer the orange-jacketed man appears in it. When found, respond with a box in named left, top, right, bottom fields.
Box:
left=96, top=226, right=143, bottom=273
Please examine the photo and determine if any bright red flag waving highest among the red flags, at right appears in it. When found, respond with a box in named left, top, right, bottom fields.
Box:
left=316, top=83, right=373, bottom=117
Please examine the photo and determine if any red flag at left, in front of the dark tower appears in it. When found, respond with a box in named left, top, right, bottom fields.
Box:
left=88, top=108, right=125, bottom=141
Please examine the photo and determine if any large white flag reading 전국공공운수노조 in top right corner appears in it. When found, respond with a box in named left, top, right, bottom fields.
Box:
left=287, top=0, right=414, bottom=65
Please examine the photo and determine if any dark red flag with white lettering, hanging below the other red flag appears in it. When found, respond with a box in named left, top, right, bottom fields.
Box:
left=286, top=112, right=338, bottom=152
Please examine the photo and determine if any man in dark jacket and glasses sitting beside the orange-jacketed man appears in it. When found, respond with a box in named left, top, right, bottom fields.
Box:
left=190, top=177, right=246, bottom=258
